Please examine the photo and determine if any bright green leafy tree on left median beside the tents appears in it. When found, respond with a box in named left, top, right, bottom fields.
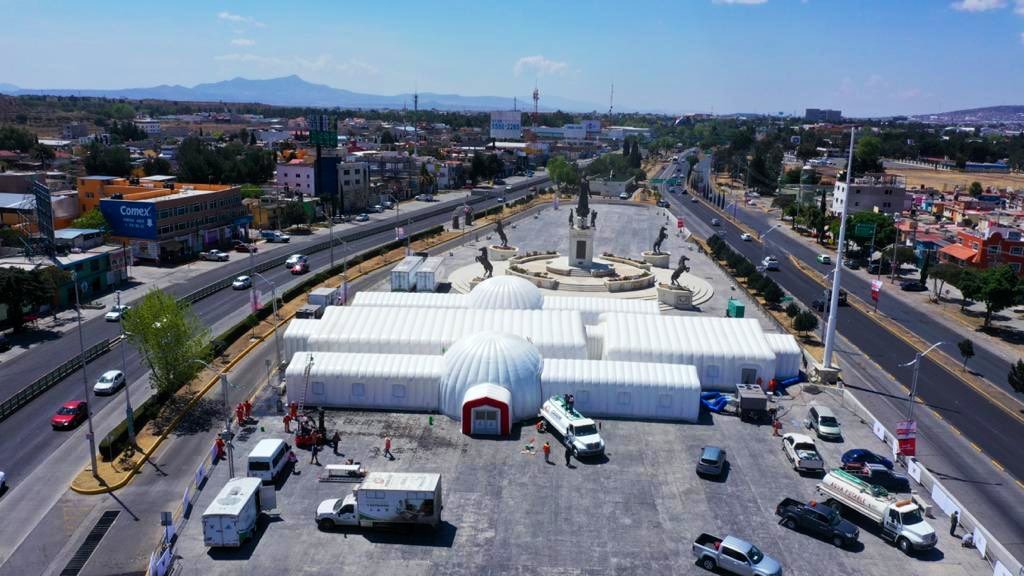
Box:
left=122, top=290, right=210, bottom=396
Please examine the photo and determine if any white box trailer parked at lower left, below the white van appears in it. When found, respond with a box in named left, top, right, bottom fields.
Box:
left=203, top=478, right=263, bottom=547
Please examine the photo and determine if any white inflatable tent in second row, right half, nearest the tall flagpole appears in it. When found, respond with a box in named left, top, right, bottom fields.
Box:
left=601, top=314, right=775, bottom=392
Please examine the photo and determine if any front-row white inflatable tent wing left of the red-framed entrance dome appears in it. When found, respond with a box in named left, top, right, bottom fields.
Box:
left=285, top=352, right=444, bottom=412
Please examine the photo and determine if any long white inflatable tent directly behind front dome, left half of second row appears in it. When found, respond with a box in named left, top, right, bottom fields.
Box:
left=306, top=307, right=587, bottom=359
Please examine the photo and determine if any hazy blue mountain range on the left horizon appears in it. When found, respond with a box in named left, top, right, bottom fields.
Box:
left=0, top=75, right=600, bottom=112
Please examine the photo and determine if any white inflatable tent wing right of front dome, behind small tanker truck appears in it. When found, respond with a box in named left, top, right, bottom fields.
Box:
left=541, top=359, right=700, bottom=422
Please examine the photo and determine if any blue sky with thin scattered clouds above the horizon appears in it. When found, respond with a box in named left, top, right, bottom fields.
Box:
left=0, top=0, right=1024, bottom=117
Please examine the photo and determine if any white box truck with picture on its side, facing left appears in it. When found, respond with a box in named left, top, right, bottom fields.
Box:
left=316, top=472, right=443, bottom=530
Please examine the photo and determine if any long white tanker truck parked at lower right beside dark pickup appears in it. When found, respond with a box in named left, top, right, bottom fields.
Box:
left=817, top=469, right=938, bottom=553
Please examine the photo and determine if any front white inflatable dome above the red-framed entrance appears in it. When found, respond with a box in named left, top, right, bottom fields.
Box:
left=440, top=327, right=544, bottom=422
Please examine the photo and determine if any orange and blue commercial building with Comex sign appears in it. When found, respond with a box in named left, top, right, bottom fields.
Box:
left=84, top=176, right=252, bottom=262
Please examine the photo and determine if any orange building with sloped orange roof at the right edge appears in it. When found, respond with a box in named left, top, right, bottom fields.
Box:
left=939, top=219, right=1024, bottom=276
